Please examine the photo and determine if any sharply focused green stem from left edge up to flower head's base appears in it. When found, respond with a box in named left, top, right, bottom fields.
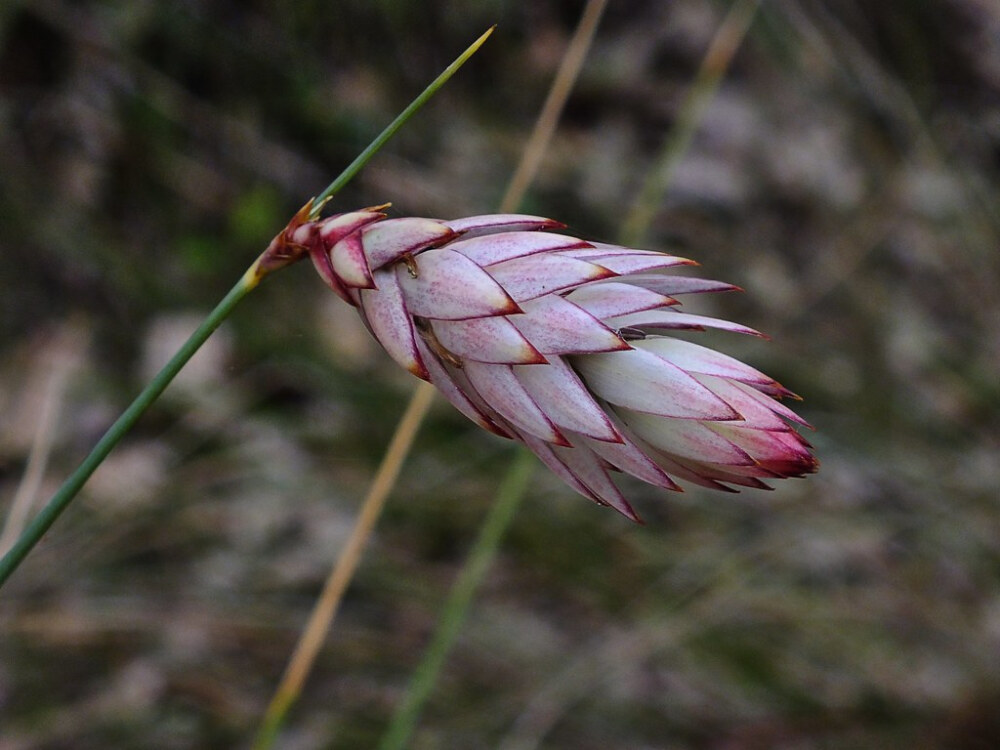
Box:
left=0, top=268, right=258, bottom=586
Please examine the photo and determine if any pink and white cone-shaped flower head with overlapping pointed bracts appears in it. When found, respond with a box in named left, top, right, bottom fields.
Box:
left=285, top=207, right=817, bottom=519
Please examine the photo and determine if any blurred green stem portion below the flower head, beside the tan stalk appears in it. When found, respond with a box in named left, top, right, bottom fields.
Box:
left=378, top=449, right=536, bottom=750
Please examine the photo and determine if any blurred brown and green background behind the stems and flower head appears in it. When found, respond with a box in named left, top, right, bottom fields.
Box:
left=0, top=0, right=1000, bottom=750
